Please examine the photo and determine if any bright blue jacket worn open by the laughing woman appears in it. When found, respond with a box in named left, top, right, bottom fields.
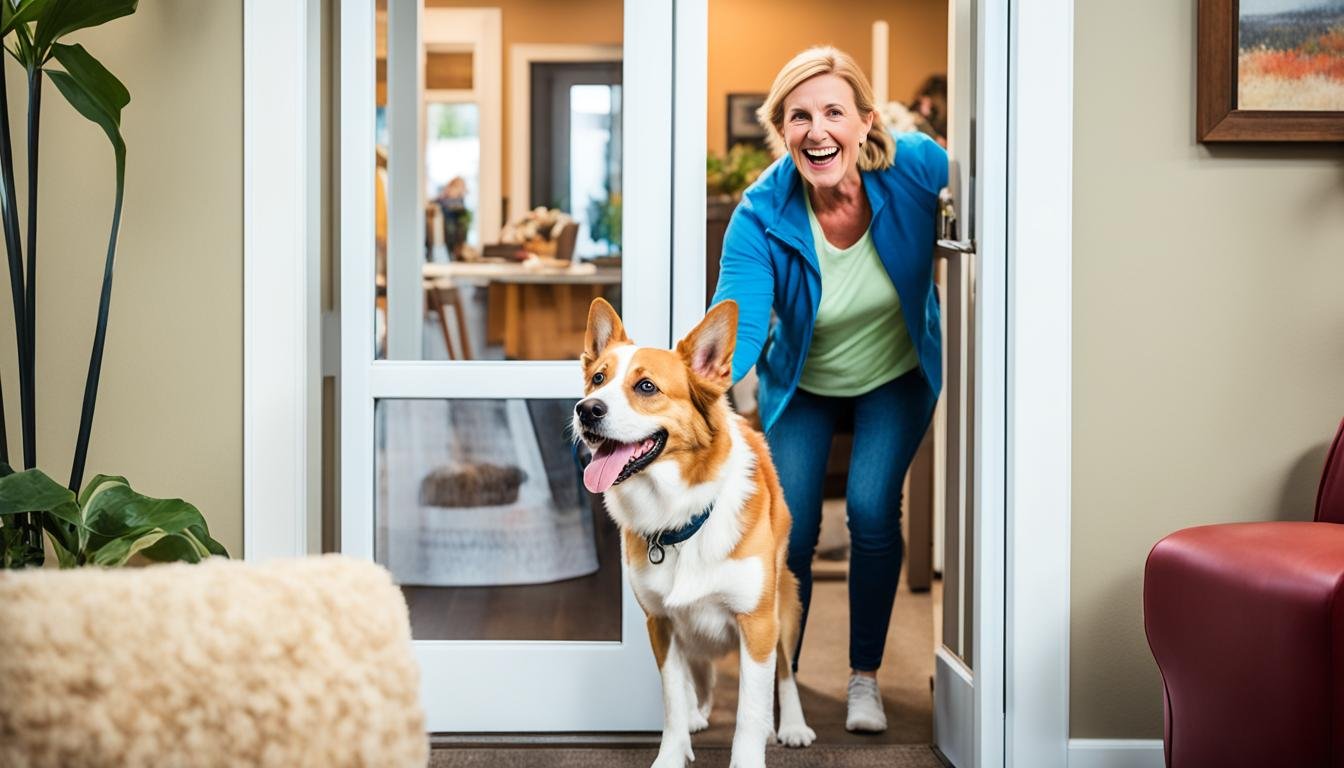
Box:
left=714, top=133, right=948, bottom=430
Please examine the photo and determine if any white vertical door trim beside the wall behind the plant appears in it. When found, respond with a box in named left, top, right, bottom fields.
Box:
left=242, top=0, right=321, bottom=561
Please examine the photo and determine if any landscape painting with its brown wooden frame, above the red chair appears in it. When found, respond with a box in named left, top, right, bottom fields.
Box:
left=1195, top=0, right=1344, bottom=143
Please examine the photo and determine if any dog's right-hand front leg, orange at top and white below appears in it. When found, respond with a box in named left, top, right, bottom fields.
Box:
left=732, top=612, right=780, bottom=768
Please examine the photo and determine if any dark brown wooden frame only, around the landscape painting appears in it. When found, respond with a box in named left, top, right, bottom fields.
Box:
left=1195, top=0, right=1344, bottom=143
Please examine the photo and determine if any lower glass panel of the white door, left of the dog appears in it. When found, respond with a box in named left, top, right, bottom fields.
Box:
left=374, top=399, right=621, bottom=640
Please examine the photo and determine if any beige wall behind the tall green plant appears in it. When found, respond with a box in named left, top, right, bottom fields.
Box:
left=0, top=0, right=243, bottom=555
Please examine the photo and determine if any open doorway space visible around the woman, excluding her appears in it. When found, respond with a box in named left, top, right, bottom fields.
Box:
left=679, top=0, right=974, bottom=765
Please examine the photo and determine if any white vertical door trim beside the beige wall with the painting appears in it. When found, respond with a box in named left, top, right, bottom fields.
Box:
left=1010, top=0, right=1074, bottom=768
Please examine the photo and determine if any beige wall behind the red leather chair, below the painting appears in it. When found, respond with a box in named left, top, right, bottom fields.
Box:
left=1071, top=0, right=1344, bottom=738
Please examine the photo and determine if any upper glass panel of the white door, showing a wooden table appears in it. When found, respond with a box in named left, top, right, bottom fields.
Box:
left=374, top=0, right=622, bottom=360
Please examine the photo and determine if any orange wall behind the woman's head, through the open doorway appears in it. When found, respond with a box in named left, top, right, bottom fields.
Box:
left=707, top=0, right=948, bottom=155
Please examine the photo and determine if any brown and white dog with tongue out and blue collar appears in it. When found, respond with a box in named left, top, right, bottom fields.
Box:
left=574, top=299, right=816, bottom=768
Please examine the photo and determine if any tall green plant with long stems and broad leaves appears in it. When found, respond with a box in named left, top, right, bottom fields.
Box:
left=0, top=0, right=227, bottom=569
